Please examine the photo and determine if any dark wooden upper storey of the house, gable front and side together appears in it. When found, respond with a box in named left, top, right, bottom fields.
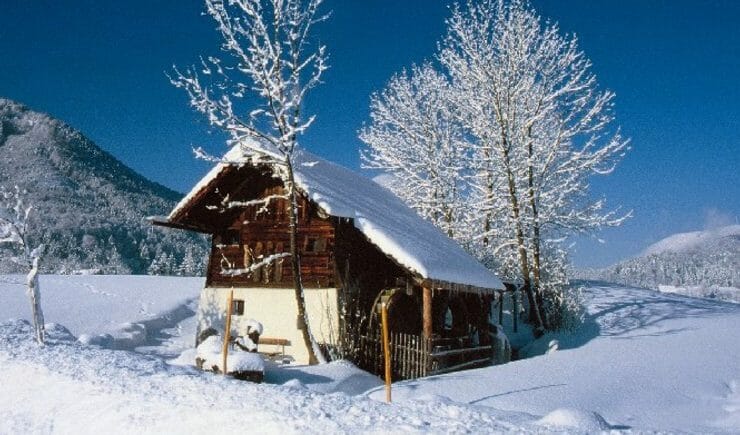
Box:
left=169, top=160, right=422, bottom=292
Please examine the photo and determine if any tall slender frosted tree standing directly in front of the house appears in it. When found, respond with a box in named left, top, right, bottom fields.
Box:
left=171, top=0, right=328, bottom=362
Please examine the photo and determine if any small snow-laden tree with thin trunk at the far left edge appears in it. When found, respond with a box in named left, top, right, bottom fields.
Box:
left=0, top=187, right=44, bottom=346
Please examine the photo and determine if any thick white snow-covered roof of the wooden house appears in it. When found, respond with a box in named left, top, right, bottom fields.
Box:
left=169, top=147, right=503, bottom=289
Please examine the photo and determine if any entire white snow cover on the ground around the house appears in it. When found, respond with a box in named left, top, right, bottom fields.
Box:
left=0, top=276, right=740, bottom=434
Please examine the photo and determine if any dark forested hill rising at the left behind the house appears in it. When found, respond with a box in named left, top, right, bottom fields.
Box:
left=0, top=98, right=207, bottom=275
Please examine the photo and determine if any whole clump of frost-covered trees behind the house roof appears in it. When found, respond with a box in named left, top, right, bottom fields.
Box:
left=360, top=0, right=627, bottom=328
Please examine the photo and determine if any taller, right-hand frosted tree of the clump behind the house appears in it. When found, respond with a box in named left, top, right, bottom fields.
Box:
left=439, top=0, right=627, bottom=325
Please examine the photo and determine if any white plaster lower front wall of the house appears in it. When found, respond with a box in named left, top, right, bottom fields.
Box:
left=198, top=287, right=339, bottom=364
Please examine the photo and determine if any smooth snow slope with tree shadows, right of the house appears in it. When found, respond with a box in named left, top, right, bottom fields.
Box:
left=371, top=286, right=740, bottom=432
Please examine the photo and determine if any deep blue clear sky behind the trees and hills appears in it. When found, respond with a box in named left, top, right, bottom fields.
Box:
left=0, top=0, right=740, bottom=266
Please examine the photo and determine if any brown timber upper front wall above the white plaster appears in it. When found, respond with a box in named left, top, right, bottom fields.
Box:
left=206, top=185, right=335, bottom=288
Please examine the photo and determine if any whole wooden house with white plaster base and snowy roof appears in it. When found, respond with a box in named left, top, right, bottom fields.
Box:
left=157, top=148, right=503, bottom=373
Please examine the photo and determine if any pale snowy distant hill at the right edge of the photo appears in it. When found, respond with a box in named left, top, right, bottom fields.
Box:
left=578, top=225, right=740, bottom=301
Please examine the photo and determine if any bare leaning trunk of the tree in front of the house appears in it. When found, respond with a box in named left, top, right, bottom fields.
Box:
left=285, top=157, right=326, bottom=364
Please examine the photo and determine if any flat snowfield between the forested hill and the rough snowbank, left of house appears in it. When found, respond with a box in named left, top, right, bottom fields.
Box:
left=0, top=275, right=204, bottom=356
